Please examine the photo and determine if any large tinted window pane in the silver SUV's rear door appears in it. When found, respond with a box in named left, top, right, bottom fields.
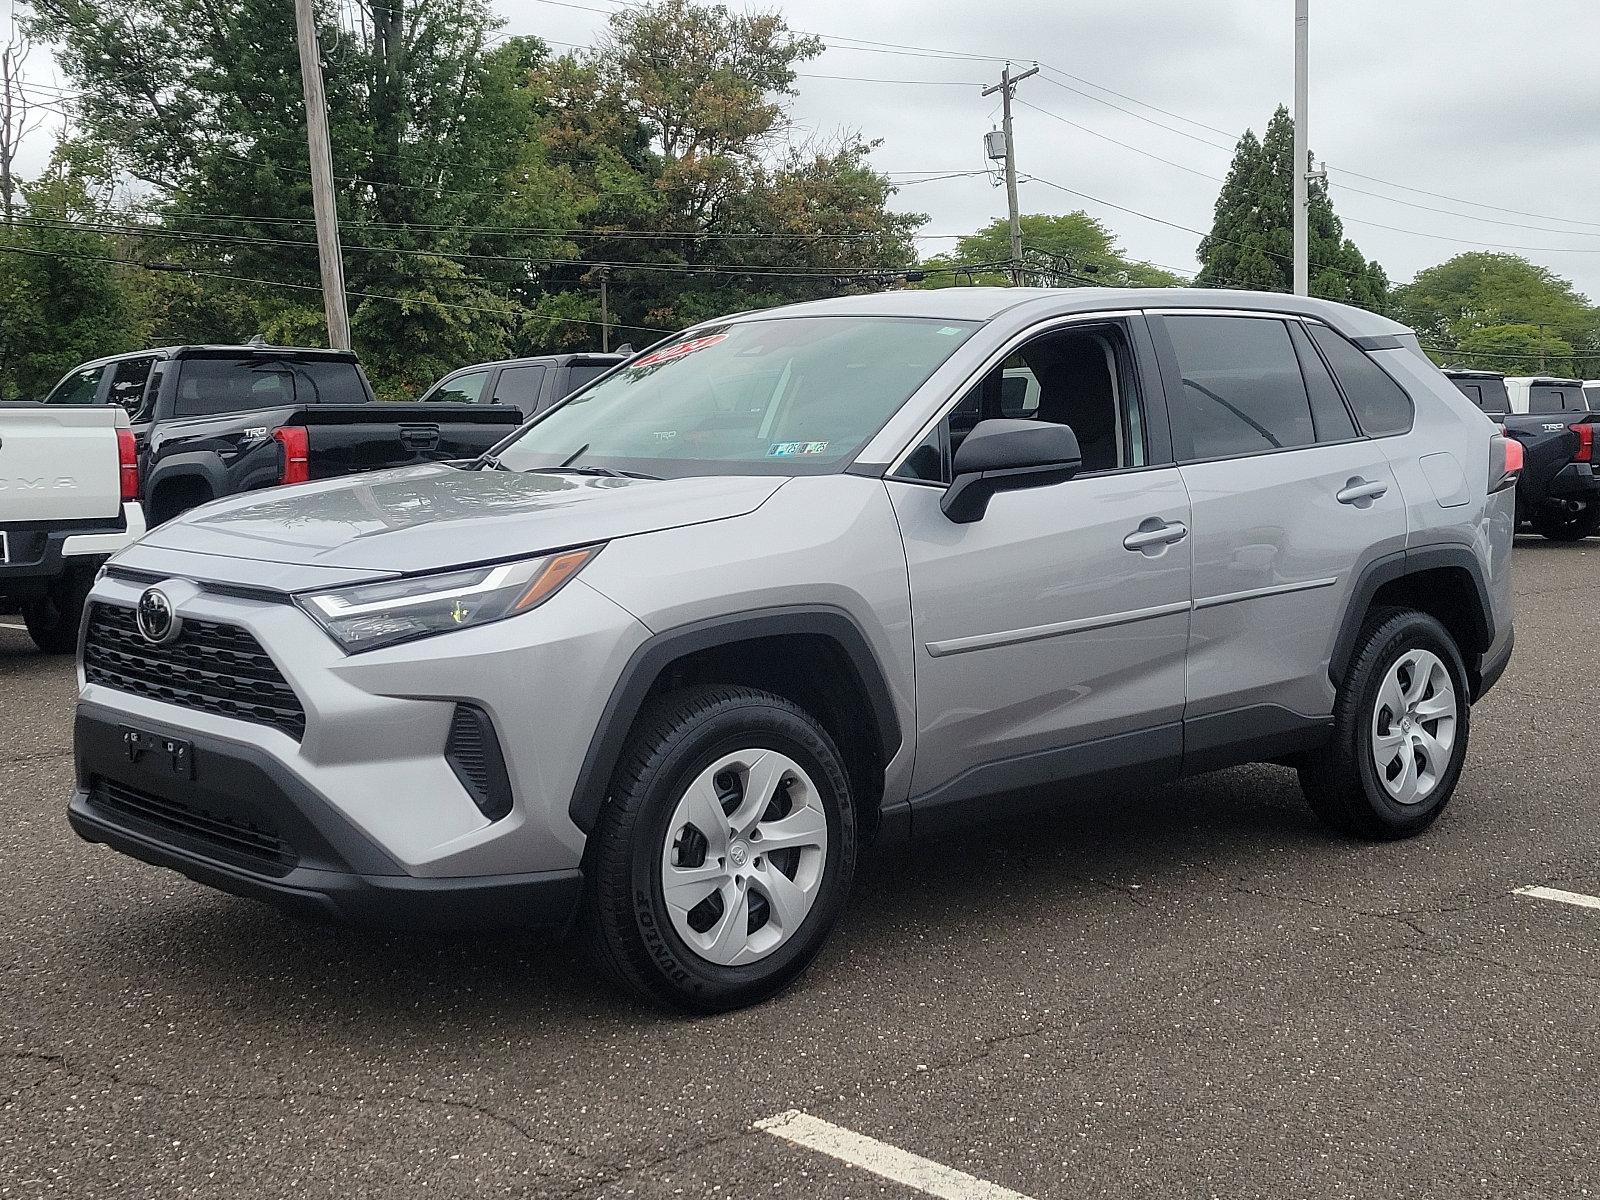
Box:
left=1163, top=315, right=1317, bottom=459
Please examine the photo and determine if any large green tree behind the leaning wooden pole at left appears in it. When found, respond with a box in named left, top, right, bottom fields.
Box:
left=35, top=0, right=582, bottom=392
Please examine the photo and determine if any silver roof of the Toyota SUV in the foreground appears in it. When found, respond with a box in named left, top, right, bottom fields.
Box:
left=702, top=288, right=1411, bottom=338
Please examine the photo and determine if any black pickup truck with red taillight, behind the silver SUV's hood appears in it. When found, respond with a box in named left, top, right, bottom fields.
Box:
left=45, top=342, right=522, bottom=525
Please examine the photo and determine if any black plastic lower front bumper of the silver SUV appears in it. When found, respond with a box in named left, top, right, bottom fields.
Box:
left=67, top=704, right=582, bottom=930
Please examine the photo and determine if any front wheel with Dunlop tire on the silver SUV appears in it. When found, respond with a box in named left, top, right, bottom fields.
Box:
left=581, top=685, right=856, bottom=1013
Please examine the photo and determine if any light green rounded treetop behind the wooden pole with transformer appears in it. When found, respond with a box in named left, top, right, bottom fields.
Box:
left=922, top=210, right=1184, bottom=288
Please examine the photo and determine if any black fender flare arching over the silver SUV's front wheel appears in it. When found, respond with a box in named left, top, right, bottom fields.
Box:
left=566, top=605, right=901, bottom=834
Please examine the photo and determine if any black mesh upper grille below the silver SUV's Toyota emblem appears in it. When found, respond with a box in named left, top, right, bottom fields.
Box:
left=83, top=603, right=306, bottom=741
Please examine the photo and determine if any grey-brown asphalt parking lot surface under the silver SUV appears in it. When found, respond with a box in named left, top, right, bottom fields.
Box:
left=0, top=539, right=1600, bottom=1200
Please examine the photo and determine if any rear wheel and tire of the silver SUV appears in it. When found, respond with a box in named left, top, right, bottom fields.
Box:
left=1299, top=608, right=1470, bottom=840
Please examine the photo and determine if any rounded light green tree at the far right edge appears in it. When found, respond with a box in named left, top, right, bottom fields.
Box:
left=1394, top=253, right=1600, bottom=374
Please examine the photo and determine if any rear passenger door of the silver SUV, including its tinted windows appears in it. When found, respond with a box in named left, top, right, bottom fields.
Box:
left=1152, top=312, right=1410, bottom=732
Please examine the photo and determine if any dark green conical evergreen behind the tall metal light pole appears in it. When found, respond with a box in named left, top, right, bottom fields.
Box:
left=1195, top=106, right=1389, bottom=312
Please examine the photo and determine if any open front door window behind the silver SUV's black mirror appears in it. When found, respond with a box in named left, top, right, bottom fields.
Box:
left=898, top=326, right=1149, bottom=483
